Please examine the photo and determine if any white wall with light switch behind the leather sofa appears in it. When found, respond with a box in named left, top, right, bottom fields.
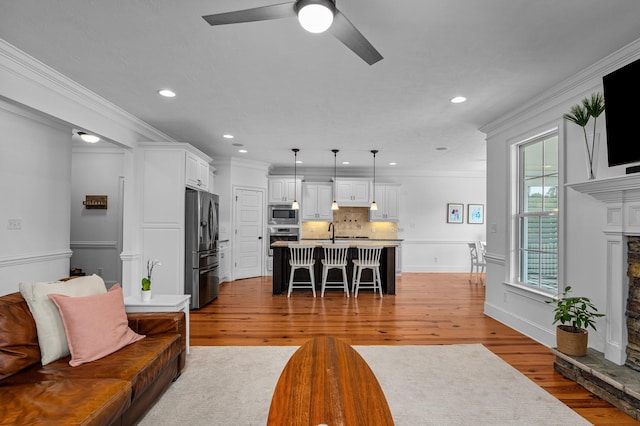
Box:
left=0, top=101, right=71, bottom=294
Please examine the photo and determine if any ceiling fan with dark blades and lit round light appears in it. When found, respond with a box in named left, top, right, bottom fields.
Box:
left=203, top=0, right=382, bottom=65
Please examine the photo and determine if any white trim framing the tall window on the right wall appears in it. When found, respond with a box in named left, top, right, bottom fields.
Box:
left=505, top=120, right=566, bottom=298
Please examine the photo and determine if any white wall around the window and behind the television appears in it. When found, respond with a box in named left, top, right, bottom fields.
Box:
left=481, top=36, right=640, bottom=351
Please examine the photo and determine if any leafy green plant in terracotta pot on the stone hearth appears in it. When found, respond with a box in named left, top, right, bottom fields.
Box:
left=547, top=286, right=604, bottom=356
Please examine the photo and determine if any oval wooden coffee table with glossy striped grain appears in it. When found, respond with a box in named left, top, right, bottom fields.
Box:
left=267, top=337, right=393, bottom=426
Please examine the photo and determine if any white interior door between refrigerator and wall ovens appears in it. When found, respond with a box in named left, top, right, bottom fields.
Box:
left=233, top=188, right=265, bottom=279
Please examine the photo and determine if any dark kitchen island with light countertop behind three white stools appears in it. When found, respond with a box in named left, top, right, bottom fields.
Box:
left=271, top=239, right=399, bottom=294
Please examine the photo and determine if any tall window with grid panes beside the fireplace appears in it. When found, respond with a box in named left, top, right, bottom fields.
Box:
left=518, top=132, right=558, bottom=293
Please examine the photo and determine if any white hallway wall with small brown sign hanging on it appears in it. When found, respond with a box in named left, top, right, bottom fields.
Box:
left=71, top=142, right=124, bottom=286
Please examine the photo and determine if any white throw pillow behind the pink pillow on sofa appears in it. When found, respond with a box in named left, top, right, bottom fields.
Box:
left=19, top=274, right=107, bottom=365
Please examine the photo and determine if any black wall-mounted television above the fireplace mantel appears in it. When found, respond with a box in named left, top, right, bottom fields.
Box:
left=602, top=59, right=640, bottom=166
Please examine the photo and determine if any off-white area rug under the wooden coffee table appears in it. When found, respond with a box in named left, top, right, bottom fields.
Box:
left=140, top=344, right=590, bottom=426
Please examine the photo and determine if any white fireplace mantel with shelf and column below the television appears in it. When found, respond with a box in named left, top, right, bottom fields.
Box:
left=566, top=174, right=640, bottom=365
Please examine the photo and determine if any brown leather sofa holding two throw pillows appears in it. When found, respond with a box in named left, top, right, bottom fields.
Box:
left=0, top=293, right=186, bottom=425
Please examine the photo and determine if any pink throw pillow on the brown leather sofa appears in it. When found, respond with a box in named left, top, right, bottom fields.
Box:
left=49, top=284, right=145, bottom=367
